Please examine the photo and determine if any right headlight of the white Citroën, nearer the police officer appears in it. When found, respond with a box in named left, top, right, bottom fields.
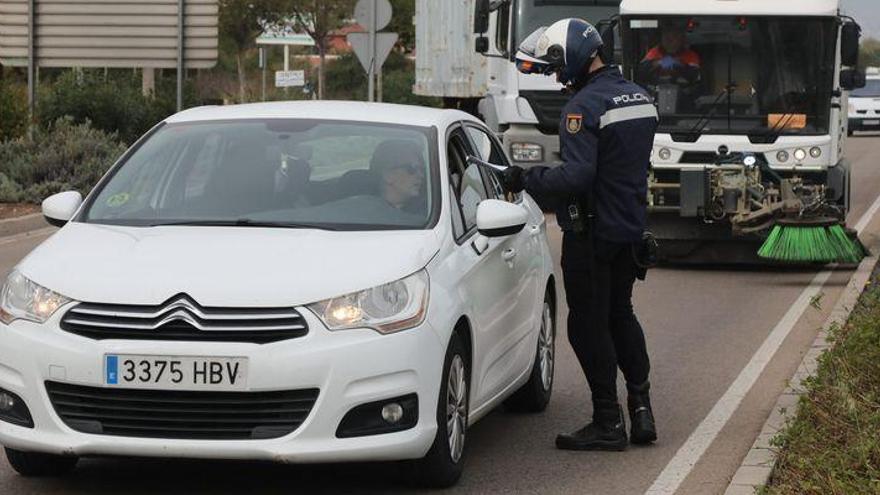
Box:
left=308, top=270, right=428, bottom=334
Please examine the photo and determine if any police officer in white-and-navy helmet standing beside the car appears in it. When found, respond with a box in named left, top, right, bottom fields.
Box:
left=504, top=19, right=658, bottom=450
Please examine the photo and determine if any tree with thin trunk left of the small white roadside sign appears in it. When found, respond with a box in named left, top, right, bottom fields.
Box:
left=219, top=0, right=285, bottom=103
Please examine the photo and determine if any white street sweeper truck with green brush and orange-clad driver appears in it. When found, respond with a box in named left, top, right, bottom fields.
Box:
left=612, top=0, right=865, bottom=262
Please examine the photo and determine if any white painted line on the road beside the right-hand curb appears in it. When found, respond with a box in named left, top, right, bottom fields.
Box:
left=645, top=196, right=880, bottom=495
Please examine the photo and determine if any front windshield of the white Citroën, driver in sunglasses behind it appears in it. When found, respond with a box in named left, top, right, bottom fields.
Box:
left=81, top=119, right=437, bottom=230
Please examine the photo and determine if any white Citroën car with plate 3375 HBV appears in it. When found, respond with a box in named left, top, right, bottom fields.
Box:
left=0, top=102, right=556, bottom=486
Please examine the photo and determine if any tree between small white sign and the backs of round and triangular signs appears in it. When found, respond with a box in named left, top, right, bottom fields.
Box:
left=288, top=0, right=355, bottom=99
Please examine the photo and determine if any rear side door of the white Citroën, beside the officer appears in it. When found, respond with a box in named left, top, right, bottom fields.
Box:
left=465, top=123, right=544, bottom=384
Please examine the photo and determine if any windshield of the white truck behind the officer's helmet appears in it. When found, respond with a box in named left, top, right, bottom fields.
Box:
left=512, top=0, right=621, bottom=48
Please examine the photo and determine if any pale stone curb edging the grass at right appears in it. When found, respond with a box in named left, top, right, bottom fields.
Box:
left=724, top=250, right=878, bottom=495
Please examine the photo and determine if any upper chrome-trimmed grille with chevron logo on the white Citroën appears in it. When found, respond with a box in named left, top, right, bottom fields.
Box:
left=61, top=294, right=308, bottom=344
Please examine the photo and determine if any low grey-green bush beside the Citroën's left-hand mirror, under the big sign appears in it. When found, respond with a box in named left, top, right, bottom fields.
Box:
left=0, top=118, right=125, bottom=203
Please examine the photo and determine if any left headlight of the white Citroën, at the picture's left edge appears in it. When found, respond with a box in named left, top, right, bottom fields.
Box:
left=0, top=270, right=71, bottom=325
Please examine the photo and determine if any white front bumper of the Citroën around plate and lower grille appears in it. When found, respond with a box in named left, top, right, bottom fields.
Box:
left=0, top=308, right=445, bottom=463
